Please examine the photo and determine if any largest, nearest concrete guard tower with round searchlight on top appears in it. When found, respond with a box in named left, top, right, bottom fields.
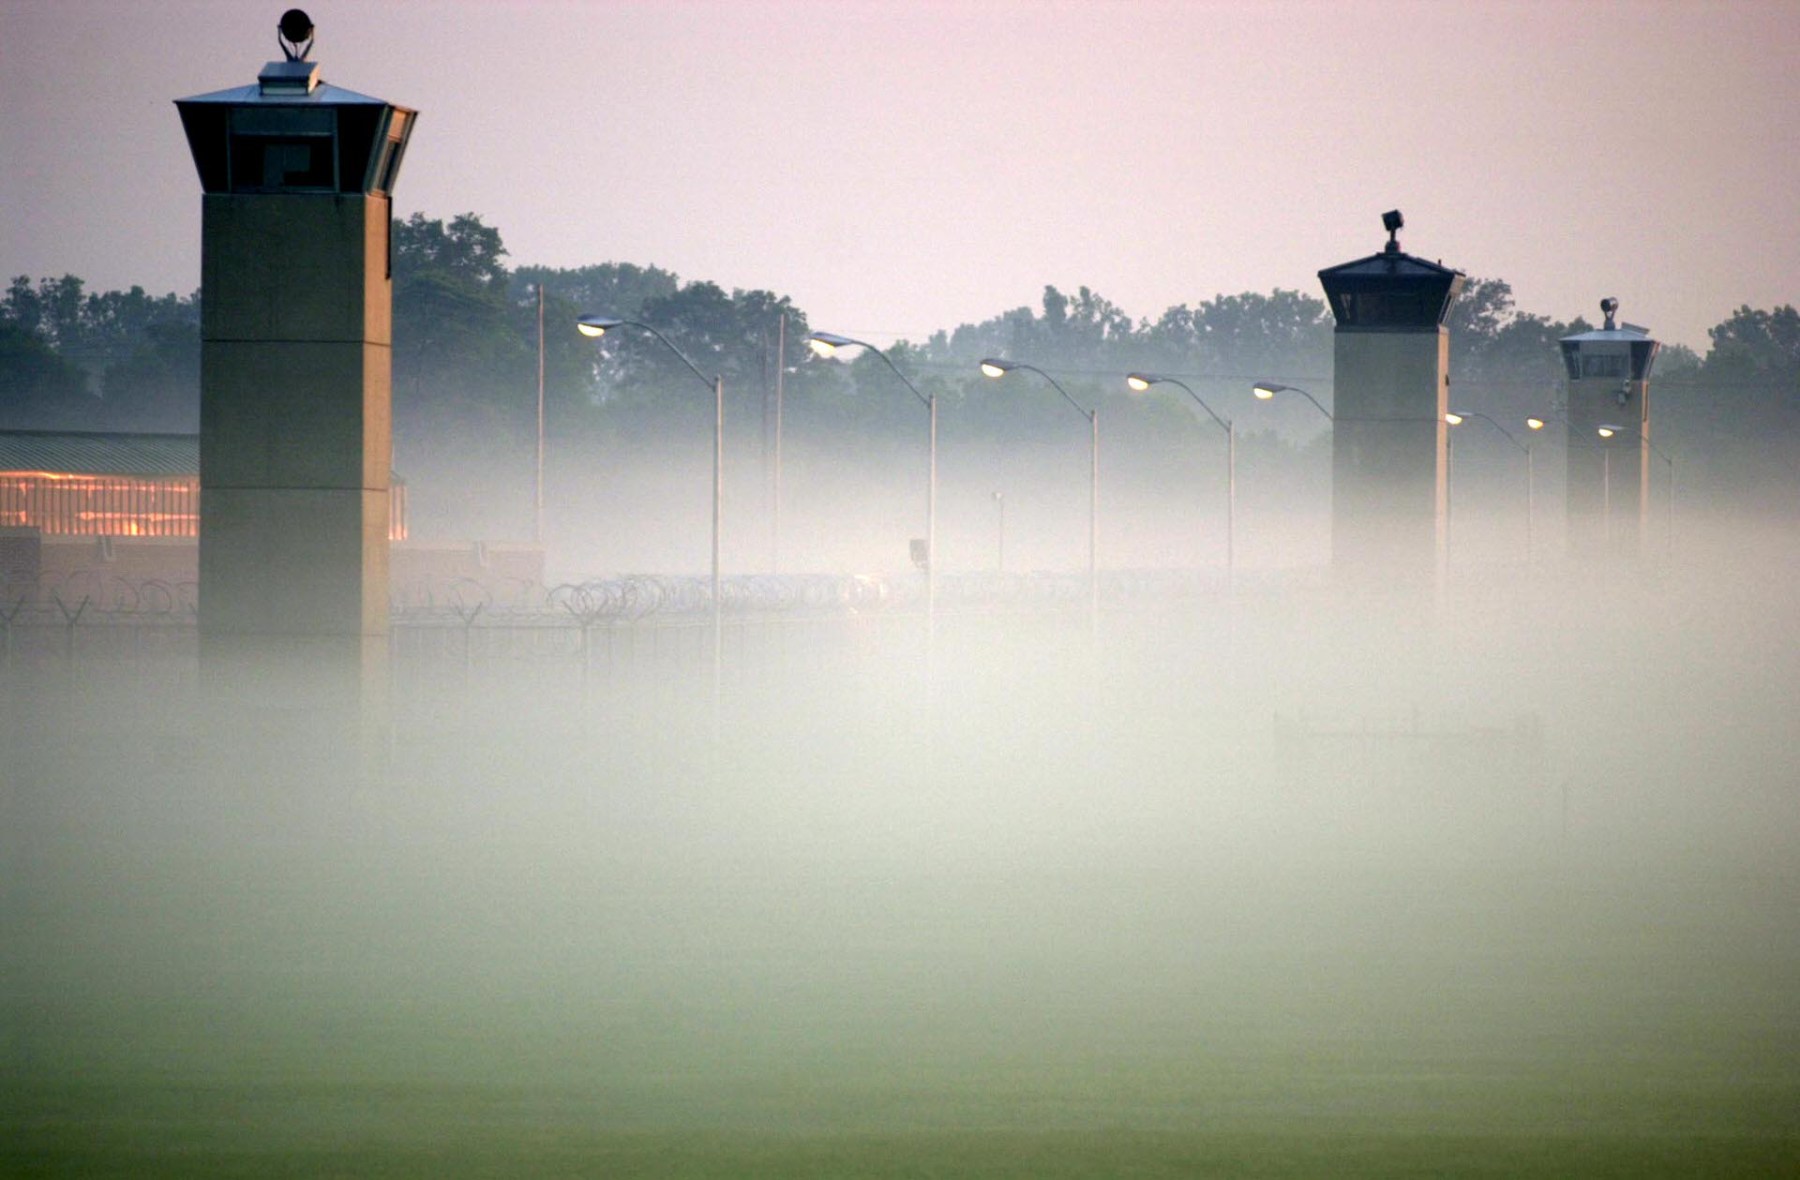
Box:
left=175, top=9, right=416, bottom=684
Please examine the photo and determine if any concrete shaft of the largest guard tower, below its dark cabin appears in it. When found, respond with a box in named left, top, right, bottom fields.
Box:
left=200, top=192, right=392, bottom=637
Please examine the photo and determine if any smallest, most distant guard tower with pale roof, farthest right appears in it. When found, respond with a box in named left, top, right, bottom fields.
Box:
left=1559, top=299, right=1663, bottom=558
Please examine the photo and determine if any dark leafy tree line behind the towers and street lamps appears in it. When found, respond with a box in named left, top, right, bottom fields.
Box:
left=0, top=214, right=1800, bottom=489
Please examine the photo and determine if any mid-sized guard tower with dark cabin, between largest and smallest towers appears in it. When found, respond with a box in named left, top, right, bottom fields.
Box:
left=1319, top=210, right=1465, bottom=585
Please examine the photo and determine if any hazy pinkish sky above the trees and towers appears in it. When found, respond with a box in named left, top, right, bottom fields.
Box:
left=0, top=0, right=1800, bottom=351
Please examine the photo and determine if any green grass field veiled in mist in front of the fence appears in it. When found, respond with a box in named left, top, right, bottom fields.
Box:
left=0, top=579, right=1800, bottom=1176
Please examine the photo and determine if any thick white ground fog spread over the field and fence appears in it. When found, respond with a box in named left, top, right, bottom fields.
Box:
left=0, top=482, right=1800, bottom=1175
